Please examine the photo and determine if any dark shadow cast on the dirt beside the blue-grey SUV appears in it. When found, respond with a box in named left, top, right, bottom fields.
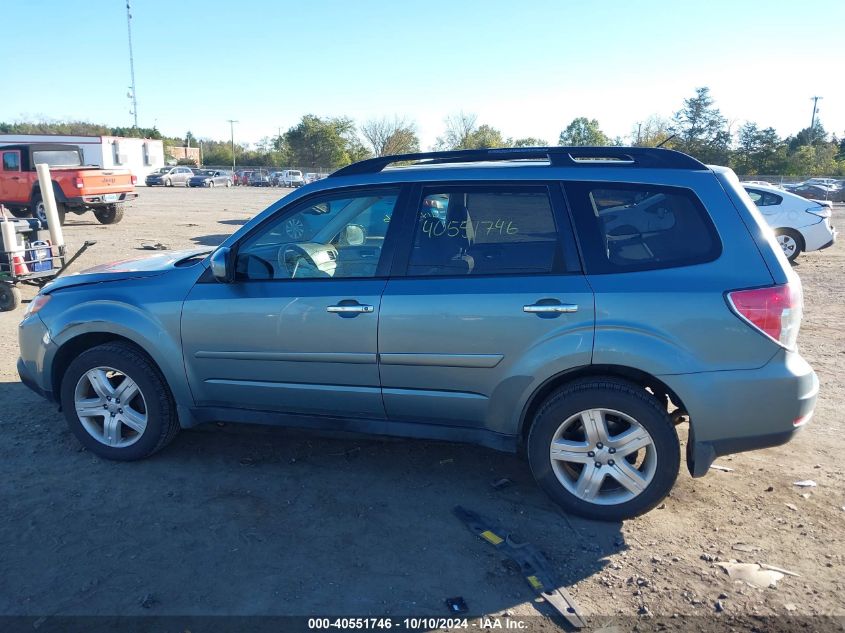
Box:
left=0, top=382, right=626, bottom=625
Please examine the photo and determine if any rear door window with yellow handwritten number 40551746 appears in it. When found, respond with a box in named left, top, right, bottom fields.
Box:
left=407, top=187, right=560, bottom=276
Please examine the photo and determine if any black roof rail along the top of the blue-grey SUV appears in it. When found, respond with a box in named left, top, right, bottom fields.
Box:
left=331, top=147, right=707, bottom=176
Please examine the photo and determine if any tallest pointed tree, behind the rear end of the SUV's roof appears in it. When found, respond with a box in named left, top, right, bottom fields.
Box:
left=672, top=88, right=731, bottom=165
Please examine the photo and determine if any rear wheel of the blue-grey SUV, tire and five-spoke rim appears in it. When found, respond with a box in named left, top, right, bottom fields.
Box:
left=527, top=377, right=681, bottom=521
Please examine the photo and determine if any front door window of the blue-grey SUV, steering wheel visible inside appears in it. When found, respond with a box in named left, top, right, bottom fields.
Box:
left=236, top=189, right=399, bottom=280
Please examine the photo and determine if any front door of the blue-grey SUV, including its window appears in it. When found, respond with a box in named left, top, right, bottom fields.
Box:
left=182, top=187, right=406, bottom=418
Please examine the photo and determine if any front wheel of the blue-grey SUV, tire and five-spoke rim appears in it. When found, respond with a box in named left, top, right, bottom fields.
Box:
left=61, top=343, right=179, bottom=461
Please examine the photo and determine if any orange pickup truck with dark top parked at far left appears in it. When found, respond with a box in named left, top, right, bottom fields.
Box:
left=0, top=143, right=138, bottom=224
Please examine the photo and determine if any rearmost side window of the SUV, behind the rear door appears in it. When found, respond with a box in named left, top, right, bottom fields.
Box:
left=565, top=183, right=722, bottom=273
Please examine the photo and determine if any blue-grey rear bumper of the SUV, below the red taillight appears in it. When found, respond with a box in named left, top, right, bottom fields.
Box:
left=660, top=350, right=819, bottom=477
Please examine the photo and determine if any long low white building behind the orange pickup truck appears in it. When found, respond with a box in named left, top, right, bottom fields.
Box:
left=0, top=134, right=164, bottom=185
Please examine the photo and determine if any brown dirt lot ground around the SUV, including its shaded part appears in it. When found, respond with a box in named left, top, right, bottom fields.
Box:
left=0, top=188, right=845, bottom=630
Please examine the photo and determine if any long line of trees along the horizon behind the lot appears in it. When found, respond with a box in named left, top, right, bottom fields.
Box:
left=0, top=87, right=845, bottom=176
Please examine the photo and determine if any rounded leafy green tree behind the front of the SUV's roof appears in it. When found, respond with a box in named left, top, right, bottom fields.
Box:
left=284, top=114, right=369, bottom=168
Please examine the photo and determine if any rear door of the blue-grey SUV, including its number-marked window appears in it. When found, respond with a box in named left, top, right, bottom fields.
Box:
left=378, top=183, right=594, bottom=434
